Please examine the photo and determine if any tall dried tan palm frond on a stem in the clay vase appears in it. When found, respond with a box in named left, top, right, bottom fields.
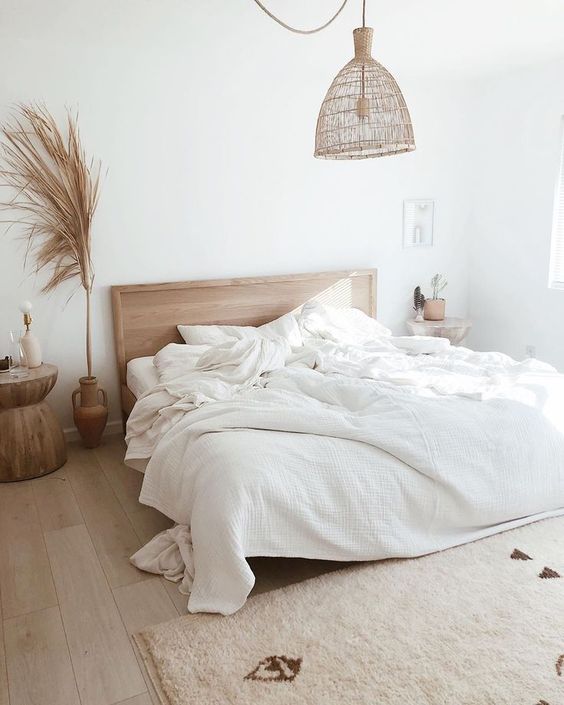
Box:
left=0, top=105, right=100, bottom=377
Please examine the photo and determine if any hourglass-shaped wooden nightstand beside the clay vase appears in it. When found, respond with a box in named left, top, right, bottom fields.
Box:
left=0, top=364, right=67, bottom=482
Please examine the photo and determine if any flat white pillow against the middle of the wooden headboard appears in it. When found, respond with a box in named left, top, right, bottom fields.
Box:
left=176, top=313, right=303, bottom=347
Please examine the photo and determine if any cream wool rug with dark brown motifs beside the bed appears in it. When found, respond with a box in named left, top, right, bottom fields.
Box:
left=136, top=517, right=564, bottom=705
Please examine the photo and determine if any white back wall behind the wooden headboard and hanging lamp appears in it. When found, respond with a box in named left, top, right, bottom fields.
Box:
left=0, top=0, right=472, bottom=426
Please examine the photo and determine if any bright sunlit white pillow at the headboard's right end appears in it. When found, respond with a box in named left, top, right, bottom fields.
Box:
left=298, top=301, right=392, bottom=345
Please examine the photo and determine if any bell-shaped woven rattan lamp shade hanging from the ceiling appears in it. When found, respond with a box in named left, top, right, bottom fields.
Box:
left=314, top=27, right=415, bottom=159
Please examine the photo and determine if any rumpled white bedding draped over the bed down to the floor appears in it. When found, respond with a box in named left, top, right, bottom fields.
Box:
left=126, top=322, right=564, bottom=614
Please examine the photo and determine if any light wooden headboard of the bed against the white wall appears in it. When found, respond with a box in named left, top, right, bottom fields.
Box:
left=112, top=270, right=376, bottom=420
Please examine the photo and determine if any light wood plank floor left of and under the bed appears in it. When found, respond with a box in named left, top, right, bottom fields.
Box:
left=0, top=437, right=342, bottom=705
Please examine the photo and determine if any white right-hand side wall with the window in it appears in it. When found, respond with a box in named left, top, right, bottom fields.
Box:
left=468, top=61, right=564, bottom=369
